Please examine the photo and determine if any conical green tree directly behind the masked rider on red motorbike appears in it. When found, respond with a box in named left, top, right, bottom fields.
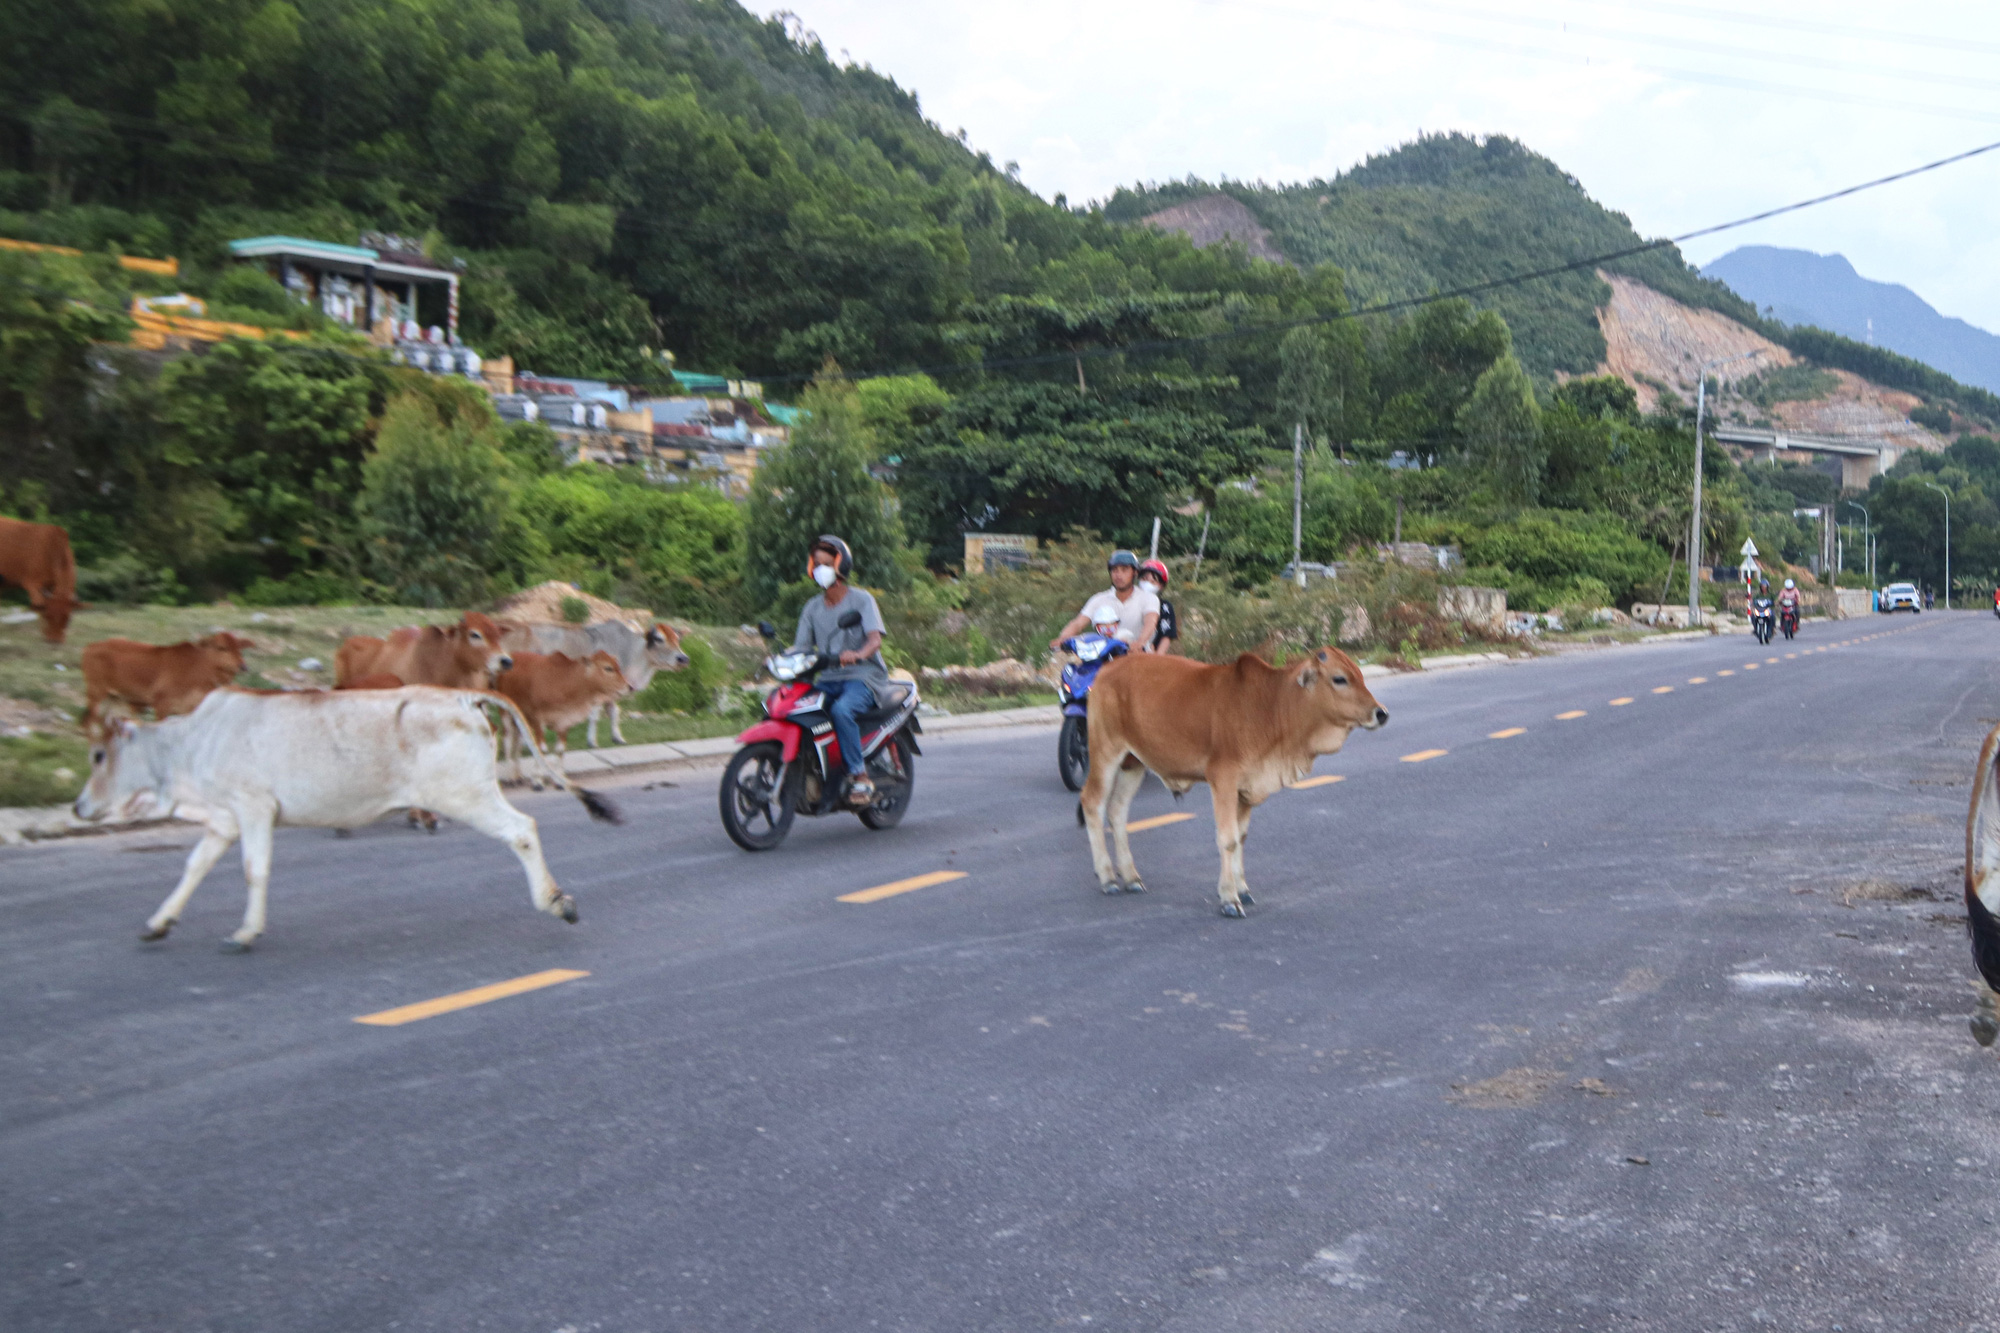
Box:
left=744, top=366, right=904, bottom=606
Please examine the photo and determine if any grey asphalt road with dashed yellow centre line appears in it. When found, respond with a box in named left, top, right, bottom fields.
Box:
left=0, top=612, right=2000, bottom=1333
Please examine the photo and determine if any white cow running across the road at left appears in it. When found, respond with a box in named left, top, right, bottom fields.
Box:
left=76, top=685, right=618, bottom=949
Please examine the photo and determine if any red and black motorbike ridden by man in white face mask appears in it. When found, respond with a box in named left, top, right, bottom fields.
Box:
left=720, top=610, right=924, bottom=851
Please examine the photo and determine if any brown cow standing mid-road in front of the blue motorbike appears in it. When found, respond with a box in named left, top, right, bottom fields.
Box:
left=1078, top=646, right=1388, bottom=917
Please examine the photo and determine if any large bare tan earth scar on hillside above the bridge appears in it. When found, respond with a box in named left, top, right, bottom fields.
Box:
left=1598, top=272, right=1946, bottom=450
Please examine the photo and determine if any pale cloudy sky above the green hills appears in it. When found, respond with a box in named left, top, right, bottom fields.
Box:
left=790, top=0, right=2000, bottom=332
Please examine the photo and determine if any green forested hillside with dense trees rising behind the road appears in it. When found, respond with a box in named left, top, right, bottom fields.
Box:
left=0, top=0, right=2000, bottom=628
